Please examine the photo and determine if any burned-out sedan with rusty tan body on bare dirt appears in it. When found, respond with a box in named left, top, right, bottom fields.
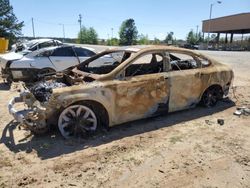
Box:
left=8, top=46, right=233, bottom=138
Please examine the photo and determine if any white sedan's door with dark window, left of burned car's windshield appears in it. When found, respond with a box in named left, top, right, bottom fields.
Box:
left=49, top=47, right=79, bottom=71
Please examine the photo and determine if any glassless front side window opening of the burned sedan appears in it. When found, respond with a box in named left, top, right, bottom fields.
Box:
left=125, top=53, right=164, bottom=77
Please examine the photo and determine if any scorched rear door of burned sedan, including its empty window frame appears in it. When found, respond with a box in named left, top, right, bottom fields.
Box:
left=166, top=53, right=202, bottom=112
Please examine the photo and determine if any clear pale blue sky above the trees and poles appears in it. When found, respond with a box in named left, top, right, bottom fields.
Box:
left=10, top=0, right=250, bottom=39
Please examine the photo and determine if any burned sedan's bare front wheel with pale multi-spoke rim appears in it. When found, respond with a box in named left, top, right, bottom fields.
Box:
left=58, top=104, right=98, bottom=139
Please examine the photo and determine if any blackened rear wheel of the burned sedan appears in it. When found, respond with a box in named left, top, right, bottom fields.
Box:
left=201, top=86, right=223, bottom=107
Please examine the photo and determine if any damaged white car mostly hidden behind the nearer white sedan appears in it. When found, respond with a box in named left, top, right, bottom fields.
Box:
left=11, top=39, right=63, bottom=55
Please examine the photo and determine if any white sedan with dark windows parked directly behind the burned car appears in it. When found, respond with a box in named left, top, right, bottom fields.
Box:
left=2, top=45, right=112, bottom=82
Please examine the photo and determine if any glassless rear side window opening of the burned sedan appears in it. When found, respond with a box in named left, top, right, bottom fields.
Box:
left=169, top=53, right=199, bottom=71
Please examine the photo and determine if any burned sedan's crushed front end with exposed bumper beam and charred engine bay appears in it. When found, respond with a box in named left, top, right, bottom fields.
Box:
left=8, top=81, right=66, bottom=134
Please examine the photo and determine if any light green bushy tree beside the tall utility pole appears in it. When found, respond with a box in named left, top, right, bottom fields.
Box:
left=78, top=27, right=98, bottom=44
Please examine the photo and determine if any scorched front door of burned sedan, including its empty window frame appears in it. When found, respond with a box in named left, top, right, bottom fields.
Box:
left=111, top=54, right=169, bottom=123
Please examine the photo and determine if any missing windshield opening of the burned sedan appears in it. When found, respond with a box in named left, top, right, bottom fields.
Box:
left=78, top=50, right=133, bottom=74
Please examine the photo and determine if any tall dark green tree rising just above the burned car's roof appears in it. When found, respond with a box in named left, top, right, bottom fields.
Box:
left=119, top=19, right=138, bottom=45
